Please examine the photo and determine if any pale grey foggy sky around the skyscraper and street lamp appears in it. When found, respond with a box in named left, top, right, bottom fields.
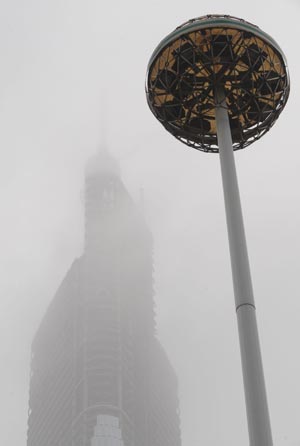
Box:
left=0, top=0, right=300, bottom=446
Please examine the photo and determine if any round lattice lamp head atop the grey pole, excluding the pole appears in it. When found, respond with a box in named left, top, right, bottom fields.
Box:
left=146, top=15, right=290, bottom=152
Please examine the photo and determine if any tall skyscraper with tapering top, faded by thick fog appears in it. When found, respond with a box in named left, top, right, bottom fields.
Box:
left=27, top=151, right=180, bottom=446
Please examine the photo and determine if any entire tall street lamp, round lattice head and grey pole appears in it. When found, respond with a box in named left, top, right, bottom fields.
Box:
left=146, top=15, right=289, bottom=446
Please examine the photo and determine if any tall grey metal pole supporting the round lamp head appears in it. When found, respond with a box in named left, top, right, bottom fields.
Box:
left=216, top=88, right=273, bottom=446
